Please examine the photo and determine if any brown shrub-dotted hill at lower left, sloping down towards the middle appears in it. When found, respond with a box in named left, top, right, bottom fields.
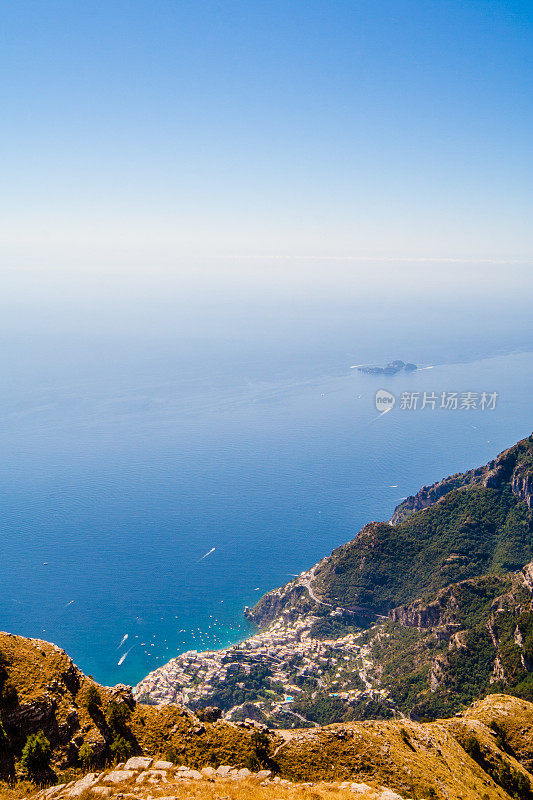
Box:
left=0, top=633, right=280, bottom=779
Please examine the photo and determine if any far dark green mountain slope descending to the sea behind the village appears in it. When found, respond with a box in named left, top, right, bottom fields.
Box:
left=248, top=436, right=533, bottom=627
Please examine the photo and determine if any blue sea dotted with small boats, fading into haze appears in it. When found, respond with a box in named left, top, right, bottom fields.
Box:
left=0, top=264, right=533, bottom=685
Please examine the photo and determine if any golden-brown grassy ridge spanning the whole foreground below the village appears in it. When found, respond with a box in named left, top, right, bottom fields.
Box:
left=5, top=633, right=533, bottom=800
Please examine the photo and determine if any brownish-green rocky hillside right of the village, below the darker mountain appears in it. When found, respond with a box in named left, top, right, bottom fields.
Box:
left=370, top=564, right=533, bottom=719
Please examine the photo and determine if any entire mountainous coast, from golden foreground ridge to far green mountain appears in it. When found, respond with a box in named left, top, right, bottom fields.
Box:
left=0, top=436, right=533, bottom=800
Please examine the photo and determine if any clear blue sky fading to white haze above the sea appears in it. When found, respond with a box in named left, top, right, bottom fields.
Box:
left=0, top=0, right=533, bottom=265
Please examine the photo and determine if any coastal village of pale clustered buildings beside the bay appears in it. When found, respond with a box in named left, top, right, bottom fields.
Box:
left=134, top=610, right=387, bottom=727
